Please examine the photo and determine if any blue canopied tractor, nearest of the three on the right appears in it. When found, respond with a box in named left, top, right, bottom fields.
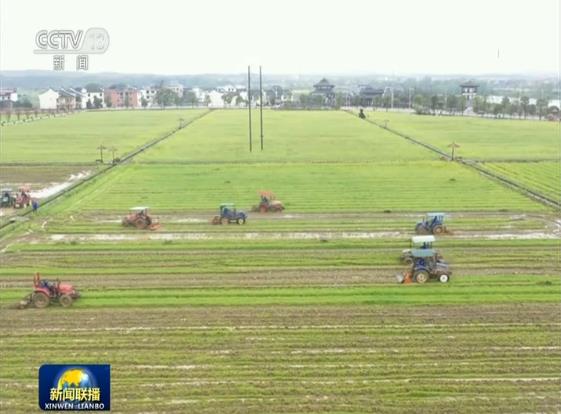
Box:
left=396, top=249, right=452, bottom=284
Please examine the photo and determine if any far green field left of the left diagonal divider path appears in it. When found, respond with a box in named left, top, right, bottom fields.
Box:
left=0, top=110, right=203, bottom=163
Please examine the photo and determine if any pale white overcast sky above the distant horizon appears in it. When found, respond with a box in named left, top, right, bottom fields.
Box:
left=0, top=0, right=560, bottom=74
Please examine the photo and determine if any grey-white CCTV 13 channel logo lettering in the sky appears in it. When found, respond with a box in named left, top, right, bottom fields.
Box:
left=33, top=27, right=109, bottom=54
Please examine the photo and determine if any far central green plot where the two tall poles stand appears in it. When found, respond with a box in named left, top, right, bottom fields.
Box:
left=140, top=110, right=437, bottom=163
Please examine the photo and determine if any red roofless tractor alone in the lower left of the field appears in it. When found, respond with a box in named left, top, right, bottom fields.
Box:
left=20, top=273, right=80, bottom=309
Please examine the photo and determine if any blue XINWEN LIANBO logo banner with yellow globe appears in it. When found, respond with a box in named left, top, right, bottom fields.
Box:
left=39, top=364, right=111, bottom=411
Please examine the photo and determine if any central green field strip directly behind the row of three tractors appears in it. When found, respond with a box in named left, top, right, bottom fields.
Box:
left=42, top=160, right=546, bottom=214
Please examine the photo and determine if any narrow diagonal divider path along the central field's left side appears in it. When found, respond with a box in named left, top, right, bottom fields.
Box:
left=0, top=109, right=212, bottom=233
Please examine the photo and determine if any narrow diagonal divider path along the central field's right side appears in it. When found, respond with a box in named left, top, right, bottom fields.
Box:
left=345, top=110, right=561, bottom=210
